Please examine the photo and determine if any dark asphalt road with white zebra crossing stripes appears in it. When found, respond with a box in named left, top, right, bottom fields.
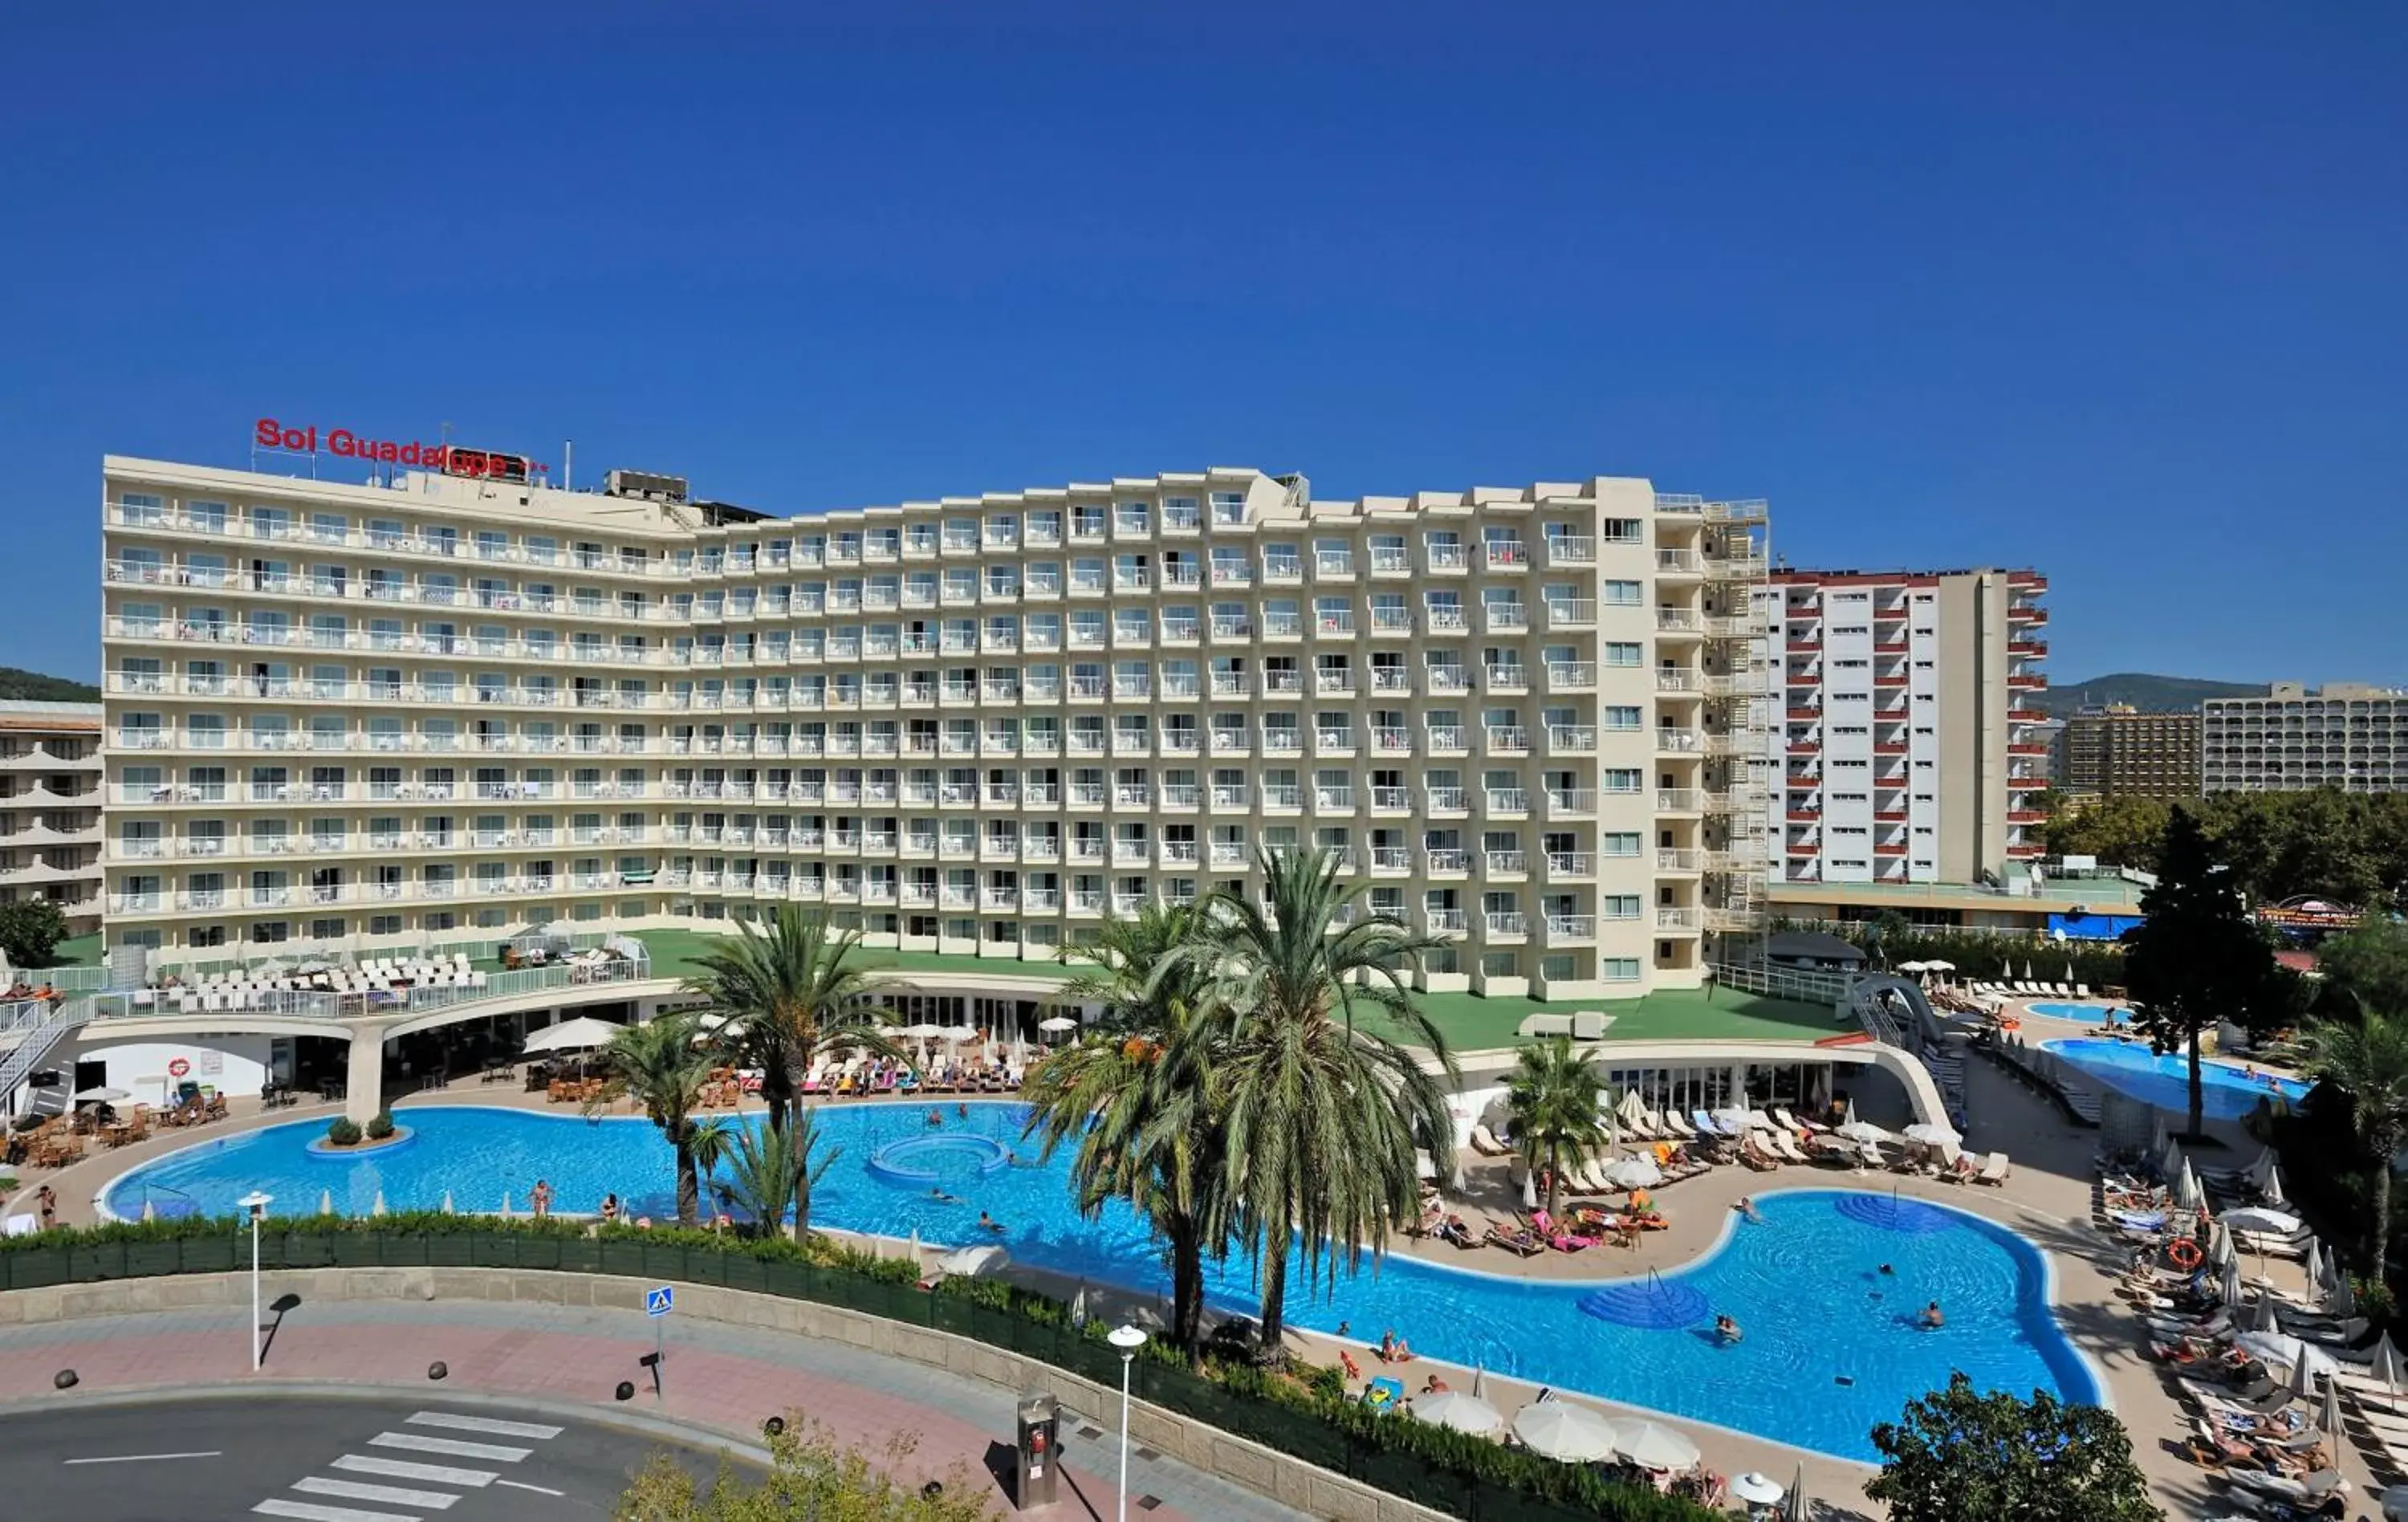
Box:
left=0, top=1392, right=718, bottom=1522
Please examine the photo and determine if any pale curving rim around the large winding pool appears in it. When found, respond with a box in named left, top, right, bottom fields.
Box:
left=94, top=1098, right=2114, bottom=1469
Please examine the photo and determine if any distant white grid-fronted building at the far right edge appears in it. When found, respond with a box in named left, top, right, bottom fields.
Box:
left=2199, top=682, right=2408, bottom=792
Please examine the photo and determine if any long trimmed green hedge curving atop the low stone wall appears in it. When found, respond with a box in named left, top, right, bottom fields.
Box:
left=0, top=1211, right=1714, bottom=1522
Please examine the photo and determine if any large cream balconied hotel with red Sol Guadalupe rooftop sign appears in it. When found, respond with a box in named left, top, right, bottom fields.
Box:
left=104, top=455, right=1767, bottom=997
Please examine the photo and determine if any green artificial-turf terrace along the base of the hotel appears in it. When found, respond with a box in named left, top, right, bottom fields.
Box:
left=636, top=930, right=1845, bottom=1052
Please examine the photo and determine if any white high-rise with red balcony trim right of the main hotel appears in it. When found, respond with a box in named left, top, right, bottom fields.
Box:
left=1758, top=568, right=2049, bottom=884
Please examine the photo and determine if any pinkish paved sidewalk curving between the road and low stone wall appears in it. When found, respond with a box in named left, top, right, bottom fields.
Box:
left=0, top=1300, right=1300, bottom=1522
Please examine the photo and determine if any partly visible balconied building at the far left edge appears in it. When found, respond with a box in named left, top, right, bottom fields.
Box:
left=0, top=701, right=101, bottom=934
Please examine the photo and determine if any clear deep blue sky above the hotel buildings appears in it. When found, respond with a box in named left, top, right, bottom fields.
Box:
left=0, top=0, right=2408, bottom=679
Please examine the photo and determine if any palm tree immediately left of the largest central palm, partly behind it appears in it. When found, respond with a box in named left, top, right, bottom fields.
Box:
left=1021, top=905, right=1228, bottom=1358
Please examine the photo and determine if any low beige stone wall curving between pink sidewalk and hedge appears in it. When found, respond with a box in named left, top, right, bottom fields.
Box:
left=0, top=1269, right=1442, bottom=1522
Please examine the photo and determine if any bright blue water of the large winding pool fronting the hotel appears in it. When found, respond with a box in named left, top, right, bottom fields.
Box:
left=106, top=1103, right=2100, bottom=1459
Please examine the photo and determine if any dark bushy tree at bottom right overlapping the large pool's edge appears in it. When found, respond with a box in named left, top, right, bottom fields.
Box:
left=1864, top=1373, right=2165, bottom=1522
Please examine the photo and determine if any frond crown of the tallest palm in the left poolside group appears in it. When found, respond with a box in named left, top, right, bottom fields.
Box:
left=686, top=903, right=898, bottom=1122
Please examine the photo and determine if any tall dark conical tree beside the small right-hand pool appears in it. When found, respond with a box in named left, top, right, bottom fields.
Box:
left=2124, top=809, right=2278, bottom=1137
